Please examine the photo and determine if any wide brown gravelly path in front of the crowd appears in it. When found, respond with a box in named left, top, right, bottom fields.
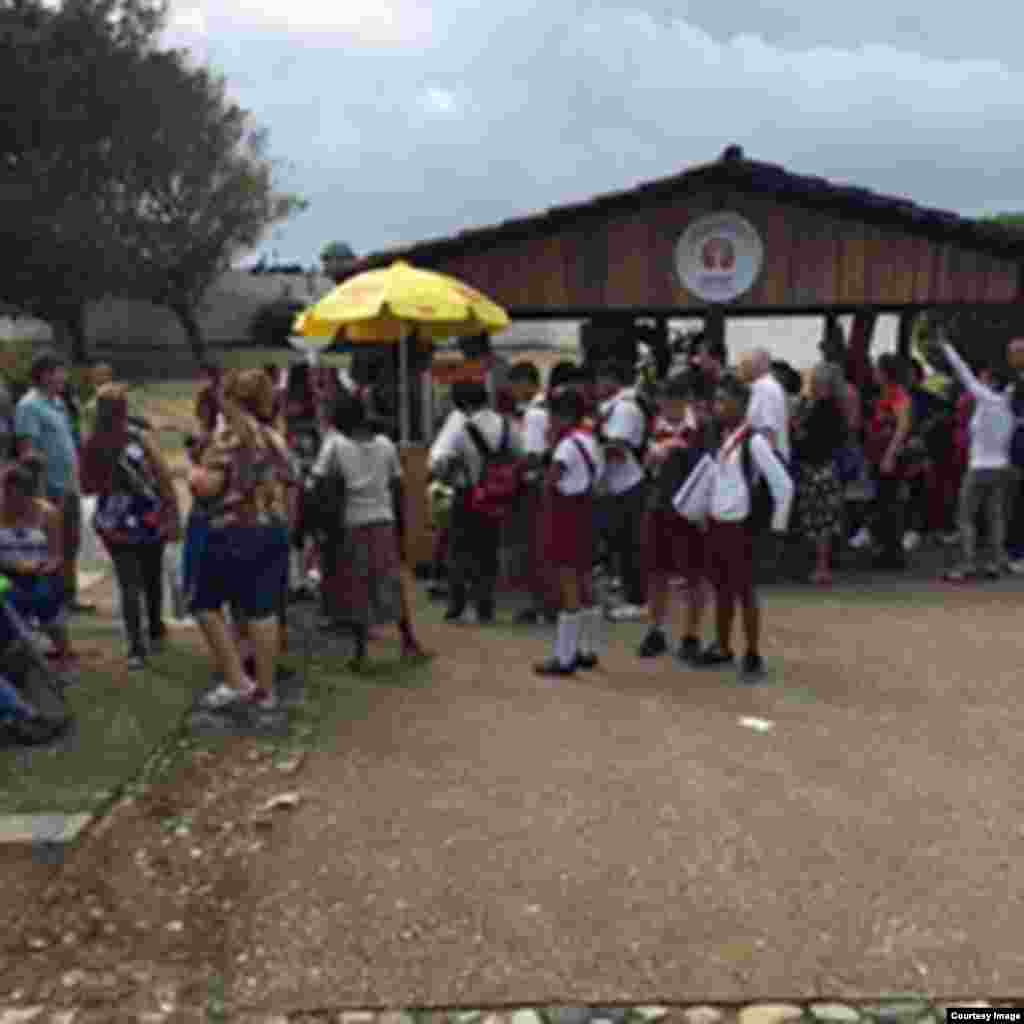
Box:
left=233, top=584, right=1024, bottom=1009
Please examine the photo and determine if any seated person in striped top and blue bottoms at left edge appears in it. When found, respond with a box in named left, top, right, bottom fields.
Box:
left=0, top=465, right=74, bottom=663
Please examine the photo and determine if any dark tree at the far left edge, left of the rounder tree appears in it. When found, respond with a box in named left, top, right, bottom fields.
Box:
left=0, top=0, right=166, bottom=359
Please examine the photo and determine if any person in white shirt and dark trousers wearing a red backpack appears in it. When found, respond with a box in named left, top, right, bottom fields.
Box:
left=430, top=381, right=522, bottom=623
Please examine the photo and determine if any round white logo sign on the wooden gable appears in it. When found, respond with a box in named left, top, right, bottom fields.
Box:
left=676, top=213, right=764, bottom=302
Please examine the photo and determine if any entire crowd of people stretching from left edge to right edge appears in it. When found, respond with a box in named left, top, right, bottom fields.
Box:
left=0, top=319, right=1024, bottom=737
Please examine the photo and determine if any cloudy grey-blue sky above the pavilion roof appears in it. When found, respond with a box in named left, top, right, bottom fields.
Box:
left=166, top=0, right=1024, bottom=265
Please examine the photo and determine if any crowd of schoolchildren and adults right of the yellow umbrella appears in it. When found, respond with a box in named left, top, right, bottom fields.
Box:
left=419, top=331, right=1024, bottom=680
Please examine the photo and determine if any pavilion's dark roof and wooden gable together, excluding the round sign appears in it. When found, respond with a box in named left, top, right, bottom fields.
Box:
left=349, top=146, right=1024, bottom=358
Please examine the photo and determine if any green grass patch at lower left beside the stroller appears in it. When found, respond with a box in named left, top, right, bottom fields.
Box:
left=0, top=623, right=210, bottom=814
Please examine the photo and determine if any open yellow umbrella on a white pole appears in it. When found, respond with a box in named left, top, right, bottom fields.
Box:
left=293, top=260, right=509, bottom=441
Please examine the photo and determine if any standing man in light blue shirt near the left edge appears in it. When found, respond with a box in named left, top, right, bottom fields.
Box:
left=14, top=352, right=94, bottom=612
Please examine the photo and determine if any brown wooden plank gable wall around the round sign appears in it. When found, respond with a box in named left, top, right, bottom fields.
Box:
left=428, top=191, right=1017, bottom=310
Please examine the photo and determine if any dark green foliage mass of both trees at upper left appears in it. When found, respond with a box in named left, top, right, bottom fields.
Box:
left=0, top=0, right=304, bottom=364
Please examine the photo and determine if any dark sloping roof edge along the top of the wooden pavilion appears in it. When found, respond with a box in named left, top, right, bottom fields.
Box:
left=350, top=146, right=1024, bottom=272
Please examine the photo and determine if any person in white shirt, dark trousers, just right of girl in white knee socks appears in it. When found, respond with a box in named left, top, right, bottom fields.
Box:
left=597, top=362, right=649, bottom=622
